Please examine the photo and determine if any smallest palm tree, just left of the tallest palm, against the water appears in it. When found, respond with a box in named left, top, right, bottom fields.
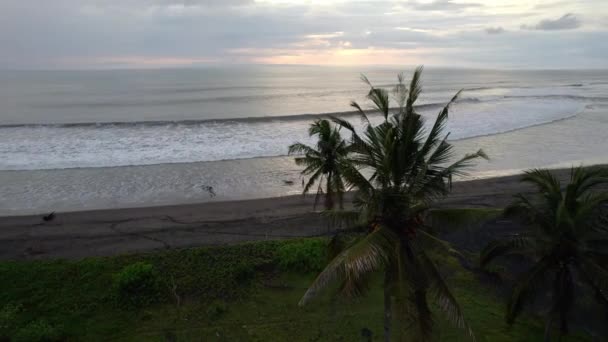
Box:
left=289, top=119, right=348, bottom=210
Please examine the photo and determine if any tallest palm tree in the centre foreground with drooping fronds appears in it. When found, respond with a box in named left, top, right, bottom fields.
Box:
left=300, top=67, right=485, bottom=341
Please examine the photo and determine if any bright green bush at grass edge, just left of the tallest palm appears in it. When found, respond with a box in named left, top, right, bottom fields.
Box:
left=276, top=239, right=328, bottom=272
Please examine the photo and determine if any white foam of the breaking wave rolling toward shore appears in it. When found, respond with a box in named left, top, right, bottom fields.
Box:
left=0, top=98, right=585, bottom=170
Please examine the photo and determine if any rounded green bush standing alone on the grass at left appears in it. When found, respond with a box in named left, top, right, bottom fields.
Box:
left=114, top=262, right=161, bottom=307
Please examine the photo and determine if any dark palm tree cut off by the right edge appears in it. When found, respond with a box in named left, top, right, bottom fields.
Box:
left=480, top=167, right=608, bottom=340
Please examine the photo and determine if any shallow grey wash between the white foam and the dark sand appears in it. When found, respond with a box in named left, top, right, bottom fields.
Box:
left=0, top=103, right=608, bottom=217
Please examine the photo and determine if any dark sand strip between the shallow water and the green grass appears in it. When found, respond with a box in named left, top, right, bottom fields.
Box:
left=0, top=169, right=600, bottom=259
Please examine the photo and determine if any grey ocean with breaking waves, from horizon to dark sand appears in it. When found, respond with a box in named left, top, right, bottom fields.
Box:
left=0, top=66, right=608, bottom=215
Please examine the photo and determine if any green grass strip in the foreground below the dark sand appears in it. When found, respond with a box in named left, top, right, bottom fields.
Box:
left=0, top=235, right=585, bottom=341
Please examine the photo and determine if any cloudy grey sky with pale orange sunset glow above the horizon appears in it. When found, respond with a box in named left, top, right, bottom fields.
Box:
left=0, top=0, right=608, bottom=69
